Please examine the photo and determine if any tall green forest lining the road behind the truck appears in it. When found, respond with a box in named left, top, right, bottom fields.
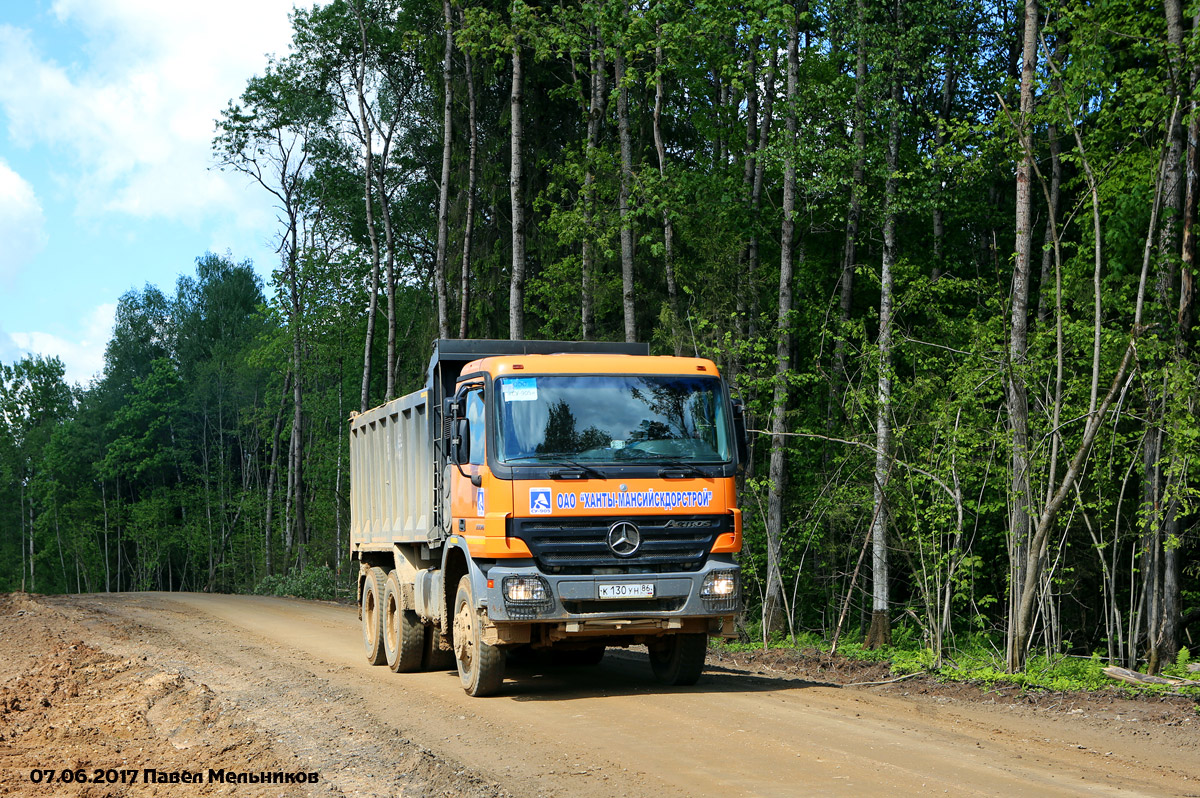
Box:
left=0, top=0, right=1200, bottom=672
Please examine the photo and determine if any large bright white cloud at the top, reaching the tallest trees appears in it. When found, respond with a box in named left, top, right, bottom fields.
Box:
left=0, top=0, right=293, bottom=223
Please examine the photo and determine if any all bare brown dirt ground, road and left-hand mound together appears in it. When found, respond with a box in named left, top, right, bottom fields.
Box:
left=0, top=593, right=1200, bottom=798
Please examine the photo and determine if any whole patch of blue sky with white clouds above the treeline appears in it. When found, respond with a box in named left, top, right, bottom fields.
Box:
left=0, top=0, right=304, bottom=384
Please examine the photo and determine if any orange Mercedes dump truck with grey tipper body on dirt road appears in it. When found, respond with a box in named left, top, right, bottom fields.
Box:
left=349, top=340, right=746, bottom=696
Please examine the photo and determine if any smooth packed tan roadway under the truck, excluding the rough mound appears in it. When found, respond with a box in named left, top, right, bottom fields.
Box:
left=0, top=594, right=1200, bottom=798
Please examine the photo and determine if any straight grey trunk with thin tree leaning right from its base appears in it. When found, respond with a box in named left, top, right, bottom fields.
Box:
left=1007, top=0, right=1038, bottom=670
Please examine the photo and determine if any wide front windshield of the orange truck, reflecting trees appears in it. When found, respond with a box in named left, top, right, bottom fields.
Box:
left=494, top=374, right=730, bottom=464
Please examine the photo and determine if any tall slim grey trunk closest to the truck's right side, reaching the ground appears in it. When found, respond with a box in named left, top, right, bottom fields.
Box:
left=762, top=8, right=799, bottom=640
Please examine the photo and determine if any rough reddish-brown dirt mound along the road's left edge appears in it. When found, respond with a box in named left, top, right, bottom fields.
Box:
left=0, top=595, right=308, bottom=798
